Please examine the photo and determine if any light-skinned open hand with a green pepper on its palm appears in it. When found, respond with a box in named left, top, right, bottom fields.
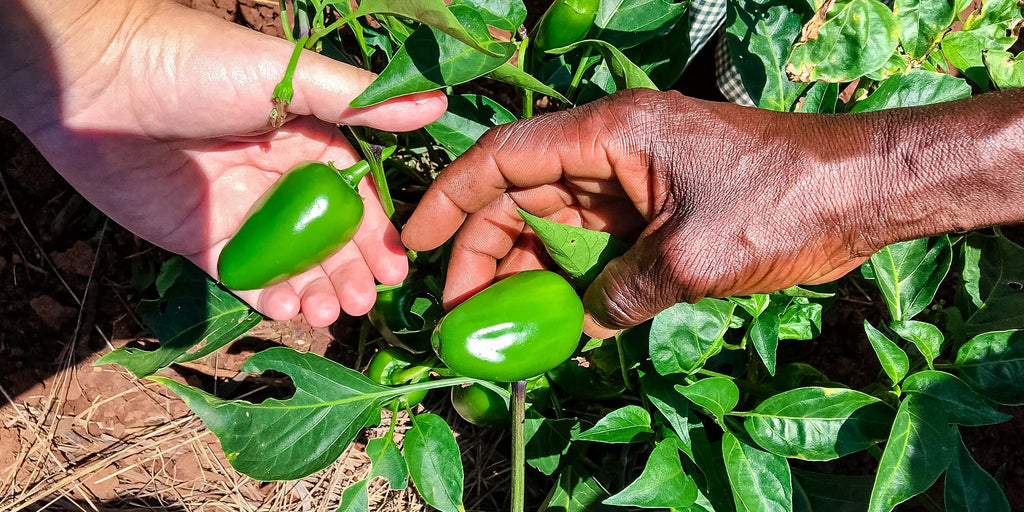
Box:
left=19, top=5, right=444, bottom=326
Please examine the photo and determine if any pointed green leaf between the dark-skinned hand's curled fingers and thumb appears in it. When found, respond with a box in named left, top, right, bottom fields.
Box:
left=518, top=208, right=629, bottom=290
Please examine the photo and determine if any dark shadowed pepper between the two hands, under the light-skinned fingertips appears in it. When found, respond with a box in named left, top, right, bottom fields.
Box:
left=367, top=280, right=442, bottom=353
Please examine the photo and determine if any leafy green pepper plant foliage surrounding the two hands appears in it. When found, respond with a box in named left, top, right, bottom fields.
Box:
left=99, top=0, right=1024, bottom=512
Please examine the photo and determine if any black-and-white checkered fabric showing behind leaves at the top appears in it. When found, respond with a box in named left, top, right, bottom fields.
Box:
left=689, top=0, right=754, bottom=106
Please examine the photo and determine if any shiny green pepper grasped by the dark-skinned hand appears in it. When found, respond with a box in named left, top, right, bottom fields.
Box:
left=430, top=270, right=583, bottom=382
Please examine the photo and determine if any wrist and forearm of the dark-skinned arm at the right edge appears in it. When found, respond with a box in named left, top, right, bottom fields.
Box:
left=865, top=90, right=1024, bottom=244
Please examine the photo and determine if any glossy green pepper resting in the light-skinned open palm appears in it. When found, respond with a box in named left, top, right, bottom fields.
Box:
left=217, top=161, right=370, bottom=290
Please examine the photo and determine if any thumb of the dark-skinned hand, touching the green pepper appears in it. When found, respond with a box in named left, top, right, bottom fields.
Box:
left=583, top=225, right=700, bottom=337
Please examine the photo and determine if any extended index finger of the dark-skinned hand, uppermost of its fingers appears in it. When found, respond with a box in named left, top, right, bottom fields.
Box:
left=402, top=109, right=611, bottom=251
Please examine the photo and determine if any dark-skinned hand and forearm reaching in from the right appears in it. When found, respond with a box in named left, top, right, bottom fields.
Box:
left=402, top=89, right=1024, bottom=337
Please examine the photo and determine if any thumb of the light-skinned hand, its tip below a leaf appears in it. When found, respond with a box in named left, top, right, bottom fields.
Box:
left=288, top=45, right=447, bottom=132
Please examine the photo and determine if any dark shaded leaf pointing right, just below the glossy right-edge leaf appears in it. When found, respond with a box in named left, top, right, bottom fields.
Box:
left=903, top=370, right=1011, bottom=427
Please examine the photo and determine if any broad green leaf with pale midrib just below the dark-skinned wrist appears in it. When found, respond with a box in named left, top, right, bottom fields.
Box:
left=868, top=234, right=952, bottom=322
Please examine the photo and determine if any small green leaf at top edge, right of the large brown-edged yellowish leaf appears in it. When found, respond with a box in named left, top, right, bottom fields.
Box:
left=893, top=0, right=956, bottom=60
